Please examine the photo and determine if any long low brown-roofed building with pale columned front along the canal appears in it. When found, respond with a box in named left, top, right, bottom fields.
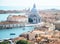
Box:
left=0, top=21, right=23, bottom=29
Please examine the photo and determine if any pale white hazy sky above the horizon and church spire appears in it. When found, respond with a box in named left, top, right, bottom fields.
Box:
left=0, top=0, right=60, bottom=9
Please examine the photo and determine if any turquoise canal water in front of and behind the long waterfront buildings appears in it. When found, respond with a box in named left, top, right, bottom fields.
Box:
left=0, top=14, right=34, bottom=40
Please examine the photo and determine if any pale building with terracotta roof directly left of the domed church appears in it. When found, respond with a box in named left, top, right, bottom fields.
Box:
left=7, top=15, right=28, bottom=23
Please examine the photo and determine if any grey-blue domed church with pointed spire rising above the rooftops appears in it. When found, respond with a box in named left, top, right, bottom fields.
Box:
left=28, top=4, right=41, bottom=24
